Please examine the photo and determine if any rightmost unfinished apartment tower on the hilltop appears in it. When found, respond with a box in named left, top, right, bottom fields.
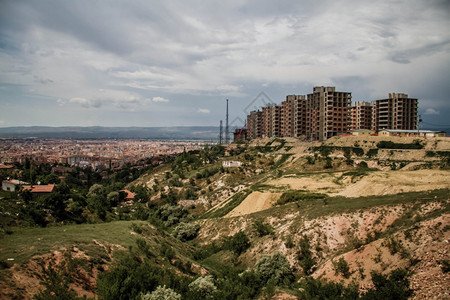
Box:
left=372, top=93, right=418, bottom=131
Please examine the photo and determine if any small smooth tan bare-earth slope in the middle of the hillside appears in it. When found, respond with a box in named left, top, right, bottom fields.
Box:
left=225, top=192, right=281, bottom=218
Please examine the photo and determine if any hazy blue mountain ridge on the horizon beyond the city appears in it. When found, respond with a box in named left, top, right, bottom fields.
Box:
left=0, top=126, right=219, bottom=140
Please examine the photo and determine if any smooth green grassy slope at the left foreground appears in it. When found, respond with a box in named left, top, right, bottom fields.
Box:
left=0, top=221, right=147, bottom=264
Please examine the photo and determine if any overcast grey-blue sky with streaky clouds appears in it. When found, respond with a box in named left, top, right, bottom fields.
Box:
left=0, top=0, right=450, bottom=127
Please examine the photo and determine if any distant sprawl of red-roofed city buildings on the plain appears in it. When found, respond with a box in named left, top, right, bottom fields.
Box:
left=0, top=139, right=216, bottom=171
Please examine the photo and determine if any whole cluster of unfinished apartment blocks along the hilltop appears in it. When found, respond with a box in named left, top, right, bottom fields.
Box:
left=243, top=86, right=436, bottom=141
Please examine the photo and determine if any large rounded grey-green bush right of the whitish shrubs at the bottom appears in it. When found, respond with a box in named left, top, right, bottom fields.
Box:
left=255, top=252, right=294, bottom=284
